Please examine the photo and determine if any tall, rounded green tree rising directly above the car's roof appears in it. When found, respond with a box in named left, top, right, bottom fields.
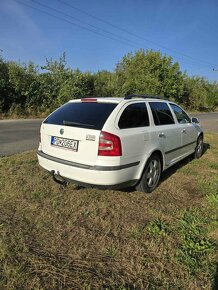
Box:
left=114, top=50, right=183, bottom=100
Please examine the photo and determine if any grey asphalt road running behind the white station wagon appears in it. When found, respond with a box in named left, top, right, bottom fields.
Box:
left=0, top=112, right=218, bottom=156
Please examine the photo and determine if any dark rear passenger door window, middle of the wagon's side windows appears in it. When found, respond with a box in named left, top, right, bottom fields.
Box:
left=149, top=102, right=175, bottom=126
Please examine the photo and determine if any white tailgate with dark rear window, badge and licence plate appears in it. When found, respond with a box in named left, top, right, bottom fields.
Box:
left=41, top=101, right=116, bottom=165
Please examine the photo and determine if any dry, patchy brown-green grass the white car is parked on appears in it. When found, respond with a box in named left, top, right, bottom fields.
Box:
left=0, top=134, right=218, bottom=290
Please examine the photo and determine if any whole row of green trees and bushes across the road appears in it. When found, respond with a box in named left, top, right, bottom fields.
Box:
left=0, top=50, right=218, bottom=116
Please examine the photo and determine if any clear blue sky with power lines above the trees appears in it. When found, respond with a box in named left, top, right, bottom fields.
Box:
left=0, top=0, right=218, bottom=81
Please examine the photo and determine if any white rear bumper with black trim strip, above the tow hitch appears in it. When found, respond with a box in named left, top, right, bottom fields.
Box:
left=37, top=151, right=140, bottom=188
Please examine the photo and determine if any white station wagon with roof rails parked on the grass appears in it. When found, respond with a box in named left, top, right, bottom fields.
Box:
left=37, top=95, right=203, bottom=192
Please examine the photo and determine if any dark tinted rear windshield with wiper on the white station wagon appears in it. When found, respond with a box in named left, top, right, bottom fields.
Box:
left=44, top=102, right=117, bottom=130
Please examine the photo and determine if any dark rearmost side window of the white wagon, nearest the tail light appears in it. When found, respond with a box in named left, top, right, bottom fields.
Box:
left=118, top=103, right=149, bottom=129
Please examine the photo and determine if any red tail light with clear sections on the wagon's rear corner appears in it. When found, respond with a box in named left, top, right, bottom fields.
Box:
left=98, top=131, right=122, bottom=156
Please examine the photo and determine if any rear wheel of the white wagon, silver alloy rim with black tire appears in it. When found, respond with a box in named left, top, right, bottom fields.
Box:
left=136, top=154, right=161, bottom=193
